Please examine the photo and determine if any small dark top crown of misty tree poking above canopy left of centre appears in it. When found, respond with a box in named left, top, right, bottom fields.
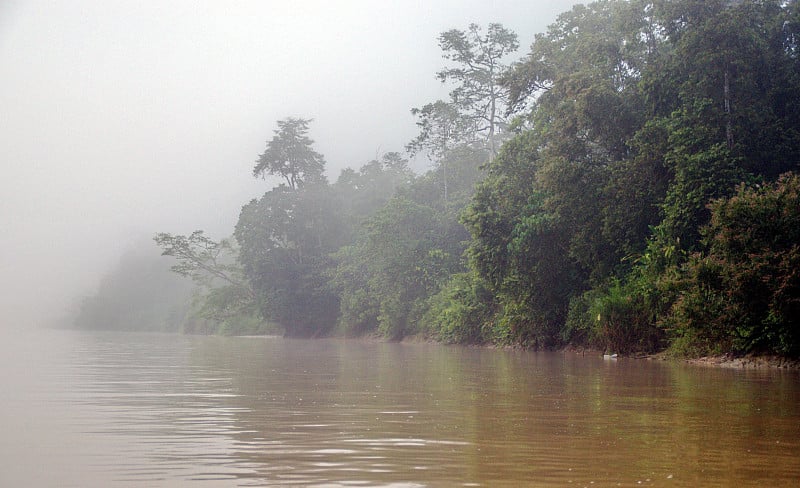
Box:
left=253, top=117, right=325, bottom=190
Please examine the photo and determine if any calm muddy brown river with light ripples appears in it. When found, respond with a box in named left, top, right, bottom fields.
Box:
left=0, top=331, right=800, bottom=488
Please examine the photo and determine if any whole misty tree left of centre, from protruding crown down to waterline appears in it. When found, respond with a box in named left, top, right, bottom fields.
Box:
left=234, top=118, right=340, bottom=336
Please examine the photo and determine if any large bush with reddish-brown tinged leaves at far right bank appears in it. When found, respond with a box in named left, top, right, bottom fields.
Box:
left=668, top=173, right=800, bottom=356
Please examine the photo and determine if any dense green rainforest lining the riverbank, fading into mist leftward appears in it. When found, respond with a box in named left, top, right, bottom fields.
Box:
left=79, top=0, right=800, bottom=356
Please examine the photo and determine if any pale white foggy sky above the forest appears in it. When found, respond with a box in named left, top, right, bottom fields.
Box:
left=0, top=0, right=578, bottom=327
